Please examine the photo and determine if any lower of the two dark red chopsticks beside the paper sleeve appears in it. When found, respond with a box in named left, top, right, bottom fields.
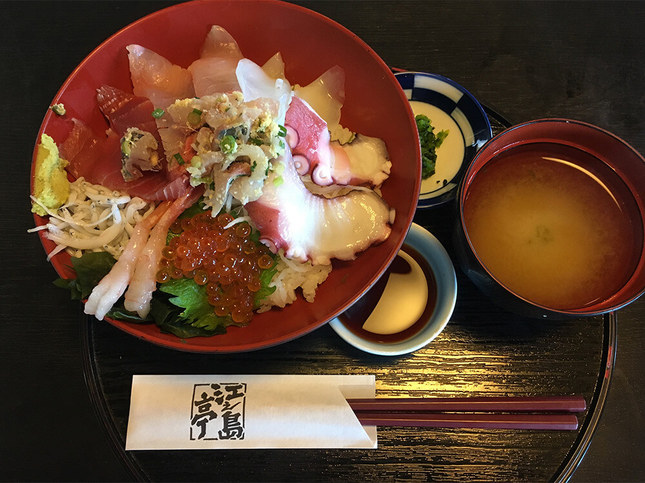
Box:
left=356, top=411, right=578, bottom=430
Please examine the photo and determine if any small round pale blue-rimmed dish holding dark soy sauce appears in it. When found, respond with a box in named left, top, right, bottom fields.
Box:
left=330, top=223, right=457, bottom=356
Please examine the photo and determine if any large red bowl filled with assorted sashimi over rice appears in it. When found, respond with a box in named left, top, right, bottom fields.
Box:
left=32, top=0, right=420, bottom=352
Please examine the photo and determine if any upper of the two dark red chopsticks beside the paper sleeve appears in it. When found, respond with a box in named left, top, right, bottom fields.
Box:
left=347, top=396, right=587, bottom=413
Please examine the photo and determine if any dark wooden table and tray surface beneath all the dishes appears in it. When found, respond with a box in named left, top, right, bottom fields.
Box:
left=0, top=0, right=645, bottom=481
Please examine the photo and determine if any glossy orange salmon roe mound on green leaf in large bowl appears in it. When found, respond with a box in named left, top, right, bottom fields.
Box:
left=157, top=212, right=273, bottom=324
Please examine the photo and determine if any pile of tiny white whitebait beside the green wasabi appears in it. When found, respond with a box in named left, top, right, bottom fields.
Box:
left=29, top=178, right=154, bottom=260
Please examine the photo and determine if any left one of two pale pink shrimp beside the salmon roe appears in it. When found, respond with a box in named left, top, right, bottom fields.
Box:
left=85, top=201, right=171, bottom=320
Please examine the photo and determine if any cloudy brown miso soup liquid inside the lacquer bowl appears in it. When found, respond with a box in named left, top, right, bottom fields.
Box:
left=463, top=143, right=643, bottom=310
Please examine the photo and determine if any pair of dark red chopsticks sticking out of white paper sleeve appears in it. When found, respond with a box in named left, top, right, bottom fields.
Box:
left=347, top=396, right=587, bottom=430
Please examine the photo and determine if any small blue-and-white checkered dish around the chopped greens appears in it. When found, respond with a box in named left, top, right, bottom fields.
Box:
left=395, top=72, right=493, bottom=208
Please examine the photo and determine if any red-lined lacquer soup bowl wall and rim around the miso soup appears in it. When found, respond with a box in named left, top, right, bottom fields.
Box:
left=457, top=118, right=645, bottom=319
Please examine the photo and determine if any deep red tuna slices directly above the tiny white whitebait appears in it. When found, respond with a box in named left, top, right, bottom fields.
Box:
left=60, top=119, right=191, bottom=201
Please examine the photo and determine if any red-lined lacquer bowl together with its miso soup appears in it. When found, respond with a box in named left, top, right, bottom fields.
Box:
left=460, top=121, right=645, bottom=320
